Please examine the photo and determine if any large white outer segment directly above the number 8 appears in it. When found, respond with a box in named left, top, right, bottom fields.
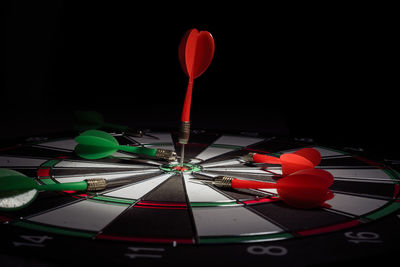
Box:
left=192, top=207, right=283, bottom=237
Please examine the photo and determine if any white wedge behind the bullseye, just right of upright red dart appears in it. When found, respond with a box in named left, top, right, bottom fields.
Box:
left=192, top=135, right=264, bottom=162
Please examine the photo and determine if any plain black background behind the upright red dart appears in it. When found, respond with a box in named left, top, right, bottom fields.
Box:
left=0, top=1, right=399, bottom=158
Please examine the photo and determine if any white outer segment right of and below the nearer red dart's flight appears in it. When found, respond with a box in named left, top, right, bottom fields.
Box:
left=326, top=193, right=387, bottom=216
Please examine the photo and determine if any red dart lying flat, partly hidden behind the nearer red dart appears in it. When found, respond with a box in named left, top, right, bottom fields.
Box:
left=243, top=148, right=321, bottom=176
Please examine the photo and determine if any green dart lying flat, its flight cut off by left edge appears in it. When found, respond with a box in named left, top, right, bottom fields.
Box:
left=0, top=169, right=147, bottom=210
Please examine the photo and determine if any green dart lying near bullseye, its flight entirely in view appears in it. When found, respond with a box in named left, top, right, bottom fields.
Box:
left=75, top=130, right=176, bottom=161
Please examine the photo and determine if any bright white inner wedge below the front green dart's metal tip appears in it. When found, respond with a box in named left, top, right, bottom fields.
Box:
left=104, top=173, right=173, bottom=199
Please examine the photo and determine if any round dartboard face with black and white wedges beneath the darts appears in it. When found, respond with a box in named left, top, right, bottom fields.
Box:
left=0, top=131, right=400, bottom=266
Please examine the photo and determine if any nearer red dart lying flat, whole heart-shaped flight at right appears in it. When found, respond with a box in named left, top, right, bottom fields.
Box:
left=192, top=168, right=333, bottom=209
